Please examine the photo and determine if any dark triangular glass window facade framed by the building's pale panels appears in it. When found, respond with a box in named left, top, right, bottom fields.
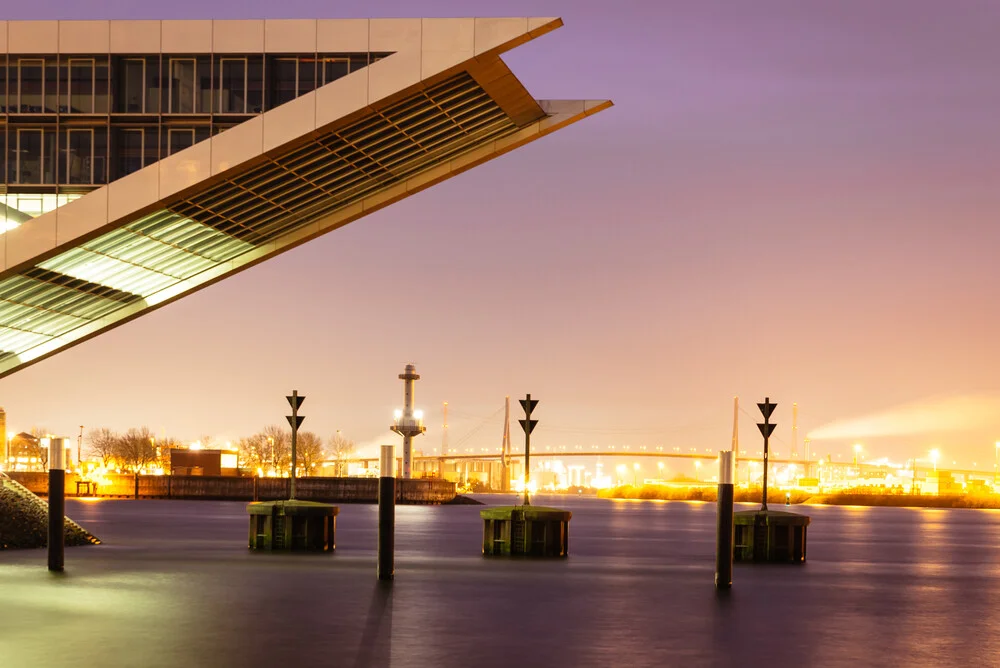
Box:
left=0, top=53, right=389, bottom=231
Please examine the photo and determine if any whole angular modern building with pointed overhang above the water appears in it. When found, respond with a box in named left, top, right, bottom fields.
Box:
left=0, top=18, right=611, bottom=377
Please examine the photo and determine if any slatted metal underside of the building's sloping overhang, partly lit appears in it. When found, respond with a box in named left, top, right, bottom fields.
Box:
left=0, top=71, right=519, bottom=370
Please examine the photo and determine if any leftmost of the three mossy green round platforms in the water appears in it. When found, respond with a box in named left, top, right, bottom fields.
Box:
left=247, top=499, right=340, bottom=553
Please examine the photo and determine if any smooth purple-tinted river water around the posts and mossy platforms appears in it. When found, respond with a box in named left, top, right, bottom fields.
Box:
left=0, top=497, right=1000, bottom=668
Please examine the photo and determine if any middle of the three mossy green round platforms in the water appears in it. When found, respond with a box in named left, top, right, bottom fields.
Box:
left=479, top=506, right=573, bottom=557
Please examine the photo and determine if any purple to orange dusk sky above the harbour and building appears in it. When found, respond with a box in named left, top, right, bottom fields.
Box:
left=0, top=0, right=1000, bottom=466
